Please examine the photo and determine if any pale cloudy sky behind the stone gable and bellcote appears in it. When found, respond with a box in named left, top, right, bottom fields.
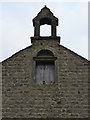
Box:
left=0, top=0, right=88, bottom=61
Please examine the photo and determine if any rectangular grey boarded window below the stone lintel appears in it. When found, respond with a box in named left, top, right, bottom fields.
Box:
left=36, top=61, right=55, bottom=84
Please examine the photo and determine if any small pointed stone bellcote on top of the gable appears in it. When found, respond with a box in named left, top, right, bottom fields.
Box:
left=31, top=6, right=60, bottom=42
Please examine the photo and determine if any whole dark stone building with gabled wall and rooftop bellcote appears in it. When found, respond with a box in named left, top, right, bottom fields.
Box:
left=2, top=6, right=89, bottom=120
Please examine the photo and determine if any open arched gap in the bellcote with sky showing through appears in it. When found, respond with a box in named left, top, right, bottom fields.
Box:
left=40, top=24, right=51, bottom=36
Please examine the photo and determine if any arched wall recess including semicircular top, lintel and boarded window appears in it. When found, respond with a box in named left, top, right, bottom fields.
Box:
left=36, top=50, right=55, bottom=84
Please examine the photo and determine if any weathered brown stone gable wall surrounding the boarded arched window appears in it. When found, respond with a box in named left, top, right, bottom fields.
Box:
left=2, top=41, right=88, bottom=118
